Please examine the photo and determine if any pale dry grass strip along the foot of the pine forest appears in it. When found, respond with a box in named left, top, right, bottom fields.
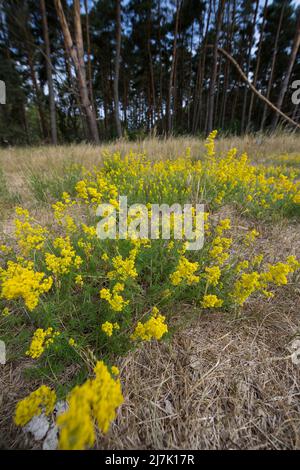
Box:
left=0, top=134, right=300, bottom=175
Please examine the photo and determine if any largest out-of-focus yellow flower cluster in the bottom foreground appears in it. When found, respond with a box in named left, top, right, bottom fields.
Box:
left=57, top=361, right=123, bottom=450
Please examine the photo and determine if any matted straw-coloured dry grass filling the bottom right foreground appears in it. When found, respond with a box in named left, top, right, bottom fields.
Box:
left=98, top=295, right=300, bottom=449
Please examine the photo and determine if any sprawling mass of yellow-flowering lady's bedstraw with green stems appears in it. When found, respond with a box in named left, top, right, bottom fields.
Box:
left=0, top=132, right=300, bottom=449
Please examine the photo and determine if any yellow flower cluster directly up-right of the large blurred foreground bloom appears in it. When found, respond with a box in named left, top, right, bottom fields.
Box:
left=131, top=307, right=168, bottom=341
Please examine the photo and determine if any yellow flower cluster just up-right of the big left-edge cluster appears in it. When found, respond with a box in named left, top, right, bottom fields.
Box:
left=45, top=236, right=82, bottom=275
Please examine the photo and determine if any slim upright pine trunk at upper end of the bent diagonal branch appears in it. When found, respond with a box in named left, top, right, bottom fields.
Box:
left=207, top=0, right=225, bottom=134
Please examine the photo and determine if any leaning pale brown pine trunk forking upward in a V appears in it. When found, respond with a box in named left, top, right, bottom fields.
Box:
left=54, top=0, right=100, bottom=144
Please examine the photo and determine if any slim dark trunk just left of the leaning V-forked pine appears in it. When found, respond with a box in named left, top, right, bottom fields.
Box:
left=41, top=0, right=57, bottom=145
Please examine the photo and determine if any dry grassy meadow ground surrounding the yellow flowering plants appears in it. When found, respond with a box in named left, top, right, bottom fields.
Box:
left=0, top=135, right=300, bottom=449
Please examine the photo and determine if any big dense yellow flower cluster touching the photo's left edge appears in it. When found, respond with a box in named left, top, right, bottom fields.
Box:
left=0, top=261, right=53, bottom=310
